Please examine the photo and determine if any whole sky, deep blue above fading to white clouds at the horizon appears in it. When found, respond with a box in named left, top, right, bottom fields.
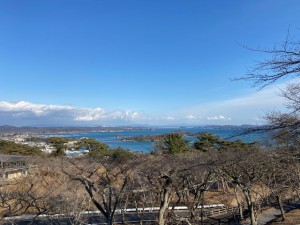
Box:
left=0, top=0, right=300, bottom=126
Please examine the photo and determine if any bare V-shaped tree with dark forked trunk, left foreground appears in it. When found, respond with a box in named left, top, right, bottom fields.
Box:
left=62, top=158, right=133, bottom=224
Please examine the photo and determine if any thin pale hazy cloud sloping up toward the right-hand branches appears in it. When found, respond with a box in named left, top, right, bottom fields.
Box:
left=178, top=80, right=287, bottom=125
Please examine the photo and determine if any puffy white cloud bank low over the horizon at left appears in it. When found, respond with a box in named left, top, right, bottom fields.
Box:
left=0, top=101, right=141, bottom=124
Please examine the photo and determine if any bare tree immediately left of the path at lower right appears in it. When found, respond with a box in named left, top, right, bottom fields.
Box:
left=219, top=149, right=269, bottom=225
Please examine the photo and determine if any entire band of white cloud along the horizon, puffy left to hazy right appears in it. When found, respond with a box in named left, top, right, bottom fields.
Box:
left=0, top=84, right=286, bottom=126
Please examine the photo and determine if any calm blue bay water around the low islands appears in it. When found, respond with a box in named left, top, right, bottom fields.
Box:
left=47, top=128, right=266, bottom=152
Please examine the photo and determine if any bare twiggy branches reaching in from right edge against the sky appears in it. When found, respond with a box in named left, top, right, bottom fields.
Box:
left=236, top=32, right=300, bottom=138
